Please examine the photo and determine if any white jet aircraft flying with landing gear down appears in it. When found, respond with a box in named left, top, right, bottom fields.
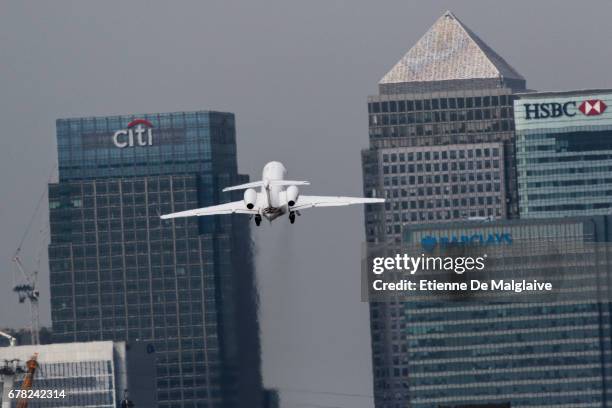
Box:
left=161, top=161, right=385, bottom=225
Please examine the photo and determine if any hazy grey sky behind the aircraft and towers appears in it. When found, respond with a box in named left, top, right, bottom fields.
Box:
left=0, top=0, right=612, bottom=408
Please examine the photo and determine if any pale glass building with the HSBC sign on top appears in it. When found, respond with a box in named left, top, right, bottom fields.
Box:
left=514, top=89, right=612, bottom=218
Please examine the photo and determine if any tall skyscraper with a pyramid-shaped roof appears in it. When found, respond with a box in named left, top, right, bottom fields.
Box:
left=362, top=12, right=526, bottom=408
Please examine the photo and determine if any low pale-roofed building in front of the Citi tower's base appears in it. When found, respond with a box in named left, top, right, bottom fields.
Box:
left=0, top=341, right=157, bottom=408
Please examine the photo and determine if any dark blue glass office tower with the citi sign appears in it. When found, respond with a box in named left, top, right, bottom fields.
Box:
left=49, top=111, right=261, bottom=408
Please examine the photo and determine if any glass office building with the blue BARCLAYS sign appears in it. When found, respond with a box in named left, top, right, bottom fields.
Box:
left=397, top=220, right=612, bottom=408
